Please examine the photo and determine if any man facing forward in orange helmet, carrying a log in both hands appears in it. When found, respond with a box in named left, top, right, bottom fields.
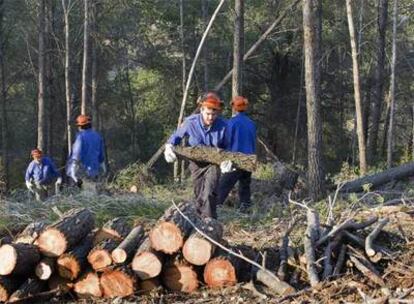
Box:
left=164, top=94, right=226, bottom=218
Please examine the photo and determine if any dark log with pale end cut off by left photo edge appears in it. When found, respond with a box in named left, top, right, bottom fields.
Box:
left=0, top=243, right=40, bottom=275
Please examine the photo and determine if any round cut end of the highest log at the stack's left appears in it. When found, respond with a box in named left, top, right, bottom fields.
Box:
left=37, top=228, right=67, bottom=257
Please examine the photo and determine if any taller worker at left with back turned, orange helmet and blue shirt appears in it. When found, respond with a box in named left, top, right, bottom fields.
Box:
left=66, top=115, right=106, bottom=190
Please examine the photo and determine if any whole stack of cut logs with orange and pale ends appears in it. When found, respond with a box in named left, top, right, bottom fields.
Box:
left=0, top=203, right=266, bottom=302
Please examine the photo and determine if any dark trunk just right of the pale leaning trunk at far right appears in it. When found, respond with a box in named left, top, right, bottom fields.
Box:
left=368, top=0, right=388, bottom=162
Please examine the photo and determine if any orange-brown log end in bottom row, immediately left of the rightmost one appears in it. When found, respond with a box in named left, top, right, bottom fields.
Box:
left=161, top=257, right=199, bottom=293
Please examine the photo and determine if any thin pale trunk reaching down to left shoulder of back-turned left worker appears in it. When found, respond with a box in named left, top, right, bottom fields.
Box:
left=62, top=0, right=72, bottom=155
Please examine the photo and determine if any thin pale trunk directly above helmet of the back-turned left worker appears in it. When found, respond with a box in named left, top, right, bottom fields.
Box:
left=81, top=0, right=89, bottom=114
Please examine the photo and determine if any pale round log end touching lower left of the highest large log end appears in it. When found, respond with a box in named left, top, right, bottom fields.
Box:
left=132, top=252, right=162, bottom=280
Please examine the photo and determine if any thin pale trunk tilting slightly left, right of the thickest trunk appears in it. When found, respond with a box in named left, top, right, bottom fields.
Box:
left=346, top=0, right=367, bottom=175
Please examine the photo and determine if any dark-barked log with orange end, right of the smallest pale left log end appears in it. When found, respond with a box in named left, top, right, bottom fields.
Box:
left=56, top=234, right=93, bottom=280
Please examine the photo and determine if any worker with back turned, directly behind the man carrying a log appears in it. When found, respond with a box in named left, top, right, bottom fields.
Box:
left=217, top=96, right=256, bottom=213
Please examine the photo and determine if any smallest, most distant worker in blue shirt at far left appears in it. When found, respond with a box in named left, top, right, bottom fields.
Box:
left=25, top=148, right=62, bottom=201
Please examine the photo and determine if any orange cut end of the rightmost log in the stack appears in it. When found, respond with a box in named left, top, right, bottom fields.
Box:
left=204, top=258, right=237, bottom=288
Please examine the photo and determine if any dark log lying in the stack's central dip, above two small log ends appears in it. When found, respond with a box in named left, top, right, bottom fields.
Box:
left=94, top=217, right=131, bottom=245
